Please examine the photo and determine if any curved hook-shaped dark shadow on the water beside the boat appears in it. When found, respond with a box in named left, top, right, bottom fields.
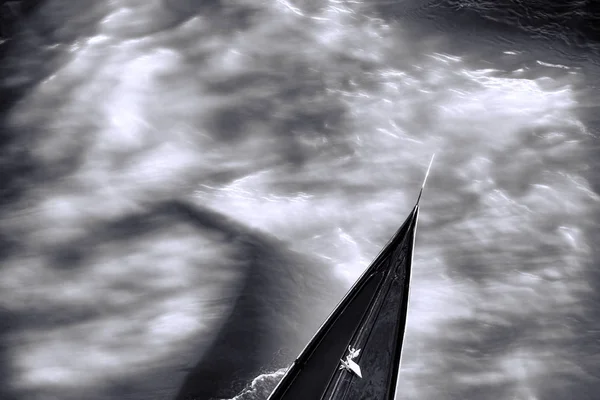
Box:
left=0, top=197, right=342, bottom=400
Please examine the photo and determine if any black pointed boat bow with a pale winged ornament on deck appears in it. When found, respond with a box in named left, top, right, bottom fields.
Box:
left=269, top=157, right=433, bottom=400
